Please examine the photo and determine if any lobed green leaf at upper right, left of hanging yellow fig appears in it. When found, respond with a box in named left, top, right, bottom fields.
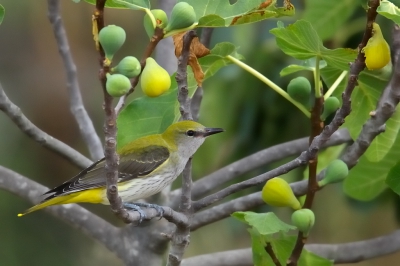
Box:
left=270, top=20, right=357, bottom=70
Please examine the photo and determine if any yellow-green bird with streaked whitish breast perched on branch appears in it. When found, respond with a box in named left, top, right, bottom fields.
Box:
left=18, top=120, right=224, bottom=221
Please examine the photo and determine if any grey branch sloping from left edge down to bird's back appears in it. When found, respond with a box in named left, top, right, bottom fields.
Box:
left=0, top=84, right=93, bottom=168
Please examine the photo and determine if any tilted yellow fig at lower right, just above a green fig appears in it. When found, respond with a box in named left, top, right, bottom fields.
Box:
left=261, top=177, right=301, bottom=210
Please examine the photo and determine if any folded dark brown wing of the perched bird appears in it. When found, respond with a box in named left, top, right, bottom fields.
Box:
left=45, top=145, right=169, bottom=197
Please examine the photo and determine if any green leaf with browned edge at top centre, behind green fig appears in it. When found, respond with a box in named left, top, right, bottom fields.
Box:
left=183, top=0, right=295, bottom=27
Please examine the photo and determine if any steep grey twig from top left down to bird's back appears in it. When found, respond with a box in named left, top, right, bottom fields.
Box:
left=47, top=0, right=104, bottom=160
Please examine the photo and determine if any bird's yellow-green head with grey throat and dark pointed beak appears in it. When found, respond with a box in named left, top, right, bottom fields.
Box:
left=162, top=120, right=224, bottom=158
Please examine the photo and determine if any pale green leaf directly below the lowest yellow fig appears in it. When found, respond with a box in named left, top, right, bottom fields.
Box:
left=232, top=212, right=296, bottom=235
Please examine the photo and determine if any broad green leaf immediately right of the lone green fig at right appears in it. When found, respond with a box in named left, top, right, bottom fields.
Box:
left=344, top=133, right=400, bottom=201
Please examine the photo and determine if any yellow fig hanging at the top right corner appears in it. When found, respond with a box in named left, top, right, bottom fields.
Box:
left=363, top=22, right=390, bottom=70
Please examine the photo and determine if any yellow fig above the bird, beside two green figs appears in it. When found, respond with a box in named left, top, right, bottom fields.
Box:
left=140, top=57, right=171, bottom=97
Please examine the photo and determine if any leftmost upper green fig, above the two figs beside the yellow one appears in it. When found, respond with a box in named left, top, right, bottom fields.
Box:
left=99, top=25, right=126, bottom=61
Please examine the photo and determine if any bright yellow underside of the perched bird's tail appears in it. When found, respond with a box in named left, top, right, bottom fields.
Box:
left=18, top=188, right=104, bottom=217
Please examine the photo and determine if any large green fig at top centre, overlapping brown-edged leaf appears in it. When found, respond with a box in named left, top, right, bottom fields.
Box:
left=164, top=2, right=196, bottom=32
